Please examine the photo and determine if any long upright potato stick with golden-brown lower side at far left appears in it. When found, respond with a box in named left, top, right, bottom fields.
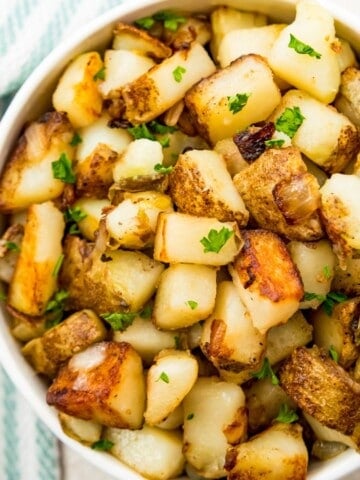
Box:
left=8, top=202, right=65, bottom=316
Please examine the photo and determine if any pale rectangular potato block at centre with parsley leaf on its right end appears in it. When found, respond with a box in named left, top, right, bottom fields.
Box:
left=154, top=212, right=242, bottom=266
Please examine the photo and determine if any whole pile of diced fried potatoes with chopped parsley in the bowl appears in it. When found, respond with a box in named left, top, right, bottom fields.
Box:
left=0, top=0, right=360, bottom=480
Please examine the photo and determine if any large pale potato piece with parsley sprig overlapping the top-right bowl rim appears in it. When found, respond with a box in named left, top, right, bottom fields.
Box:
left=269, top=0, right=340, bottom=103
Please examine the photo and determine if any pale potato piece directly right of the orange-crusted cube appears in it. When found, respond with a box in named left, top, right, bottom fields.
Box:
left=288, top=239, right=336, bottom=308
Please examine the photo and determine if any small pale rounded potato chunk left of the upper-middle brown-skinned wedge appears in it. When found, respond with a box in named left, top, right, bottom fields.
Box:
left=113, top=138, right=164, bottom=182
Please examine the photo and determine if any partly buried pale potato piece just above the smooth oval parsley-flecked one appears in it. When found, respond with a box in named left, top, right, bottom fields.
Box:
left=113, top=316, right=182, bottom=364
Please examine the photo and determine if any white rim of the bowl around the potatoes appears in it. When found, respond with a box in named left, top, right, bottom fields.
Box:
left=0, top=0, right=360, bottom=480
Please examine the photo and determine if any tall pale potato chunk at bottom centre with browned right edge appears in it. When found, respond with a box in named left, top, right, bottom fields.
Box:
left=184, top=377, right=247, bottom=478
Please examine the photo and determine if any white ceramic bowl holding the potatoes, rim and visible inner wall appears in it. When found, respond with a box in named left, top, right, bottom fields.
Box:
left=0, top=0, right=360, bottom=480
